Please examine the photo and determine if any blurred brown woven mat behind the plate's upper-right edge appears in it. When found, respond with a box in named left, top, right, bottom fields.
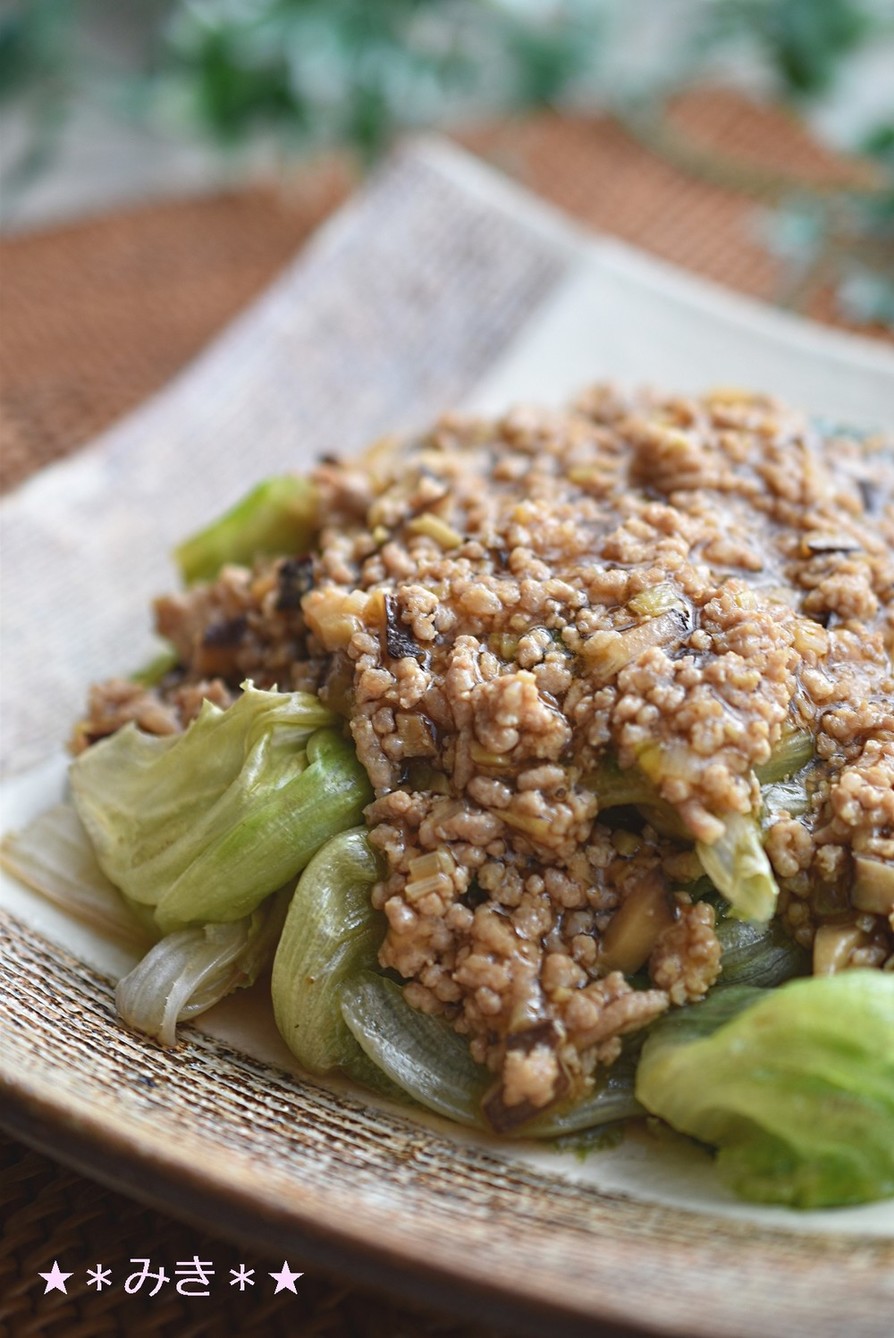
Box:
left=467, top=90, right=878, bottom=315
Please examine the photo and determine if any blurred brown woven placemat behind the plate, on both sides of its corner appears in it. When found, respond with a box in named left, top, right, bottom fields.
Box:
left=0, top=90, right=889, bottom=488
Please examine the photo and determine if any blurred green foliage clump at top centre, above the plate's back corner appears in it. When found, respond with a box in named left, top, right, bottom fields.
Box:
left=163, top=0, right=601, bottom=159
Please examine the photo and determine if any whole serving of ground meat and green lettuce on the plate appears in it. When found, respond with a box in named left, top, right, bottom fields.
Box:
left=3, top=385, right=894, bottom=1206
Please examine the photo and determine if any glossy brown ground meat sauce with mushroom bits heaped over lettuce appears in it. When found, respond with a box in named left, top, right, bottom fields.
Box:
left=82, top=387, right=894, bottom=1127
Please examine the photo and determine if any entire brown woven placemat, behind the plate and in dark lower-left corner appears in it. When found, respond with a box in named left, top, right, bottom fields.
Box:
left=0, top=92, right=888, bottom=1338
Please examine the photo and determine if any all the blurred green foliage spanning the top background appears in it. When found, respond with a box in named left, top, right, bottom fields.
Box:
left=0, top=0, right=894, bottom=324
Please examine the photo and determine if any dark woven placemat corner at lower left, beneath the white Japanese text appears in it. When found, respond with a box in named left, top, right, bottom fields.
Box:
left=0, top=1133, right=501, bottom=1338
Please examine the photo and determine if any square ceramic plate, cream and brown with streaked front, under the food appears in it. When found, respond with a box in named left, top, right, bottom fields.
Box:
left=0, top=142, right=894, bottom=1338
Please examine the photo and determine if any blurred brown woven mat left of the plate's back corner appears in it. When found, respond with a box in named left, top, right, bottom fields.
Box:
left=0, top=171, right=345, bottom=487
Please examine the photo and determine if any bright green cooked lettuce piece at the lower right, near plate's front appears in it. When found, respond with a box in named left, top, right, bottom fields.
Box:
left=636, top=970, right=894, bottom=1208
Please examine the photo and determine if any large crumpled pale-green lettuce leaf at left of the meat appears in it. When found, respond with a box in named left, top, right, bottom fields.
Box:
left=71, top=684, right=371, bottom=934
